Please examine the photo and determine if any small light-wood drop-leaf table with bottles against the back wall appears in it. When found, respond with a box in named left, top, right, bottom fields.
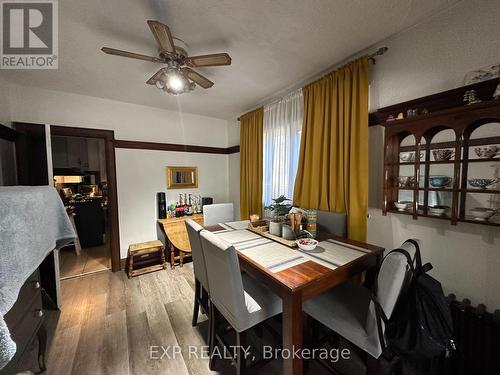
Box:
left=157, top=214, right=204, bottom=269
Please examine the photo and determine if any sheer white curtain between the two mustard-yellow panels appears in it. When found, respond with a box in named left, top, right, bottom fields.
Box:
left=263, top=89, right=304, bottom=206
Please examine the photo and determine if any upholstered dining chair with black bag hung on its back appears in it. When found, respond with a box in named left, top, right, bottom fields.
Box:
left=303, top=240, right=420, bottom=374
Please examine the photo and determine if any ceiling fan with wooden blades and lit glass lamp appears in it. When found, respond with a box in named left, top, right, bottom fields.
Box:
left=101, top=20, right=231, bottom=95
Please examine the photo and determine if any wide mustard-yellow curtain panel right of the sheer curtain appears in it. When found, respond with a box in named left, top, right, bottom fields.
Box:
left=293, top=57, right=368, bottom=241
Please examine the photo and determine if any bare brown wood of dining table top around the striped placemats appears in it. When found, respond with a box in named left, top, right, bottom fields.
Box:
left=205, top=225, right=384, bottom=298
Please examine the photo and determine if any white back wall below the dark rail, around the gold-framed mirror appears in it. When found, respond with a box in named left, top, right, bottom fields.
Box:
left=116, top=149, right=228, bottom=258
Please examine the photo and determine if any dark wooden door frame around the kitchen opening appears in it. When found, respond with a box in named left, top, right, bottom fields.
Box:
left=50, top=125, right=121, bottom=272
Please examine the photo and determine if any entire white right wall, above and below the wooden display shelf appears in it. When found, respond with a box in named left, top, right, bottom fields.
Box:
left=368, top=0, right=500, bottom=310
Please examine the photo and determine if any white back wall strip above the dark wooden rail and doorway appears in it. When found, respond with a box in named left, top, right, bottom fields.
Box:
left=7, top=85, right=227, bottom=147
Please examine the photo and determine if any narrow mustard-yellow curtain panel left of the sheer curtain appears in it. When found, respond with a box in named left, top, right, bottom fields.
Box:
left=240, top=107, right=264, bottom=219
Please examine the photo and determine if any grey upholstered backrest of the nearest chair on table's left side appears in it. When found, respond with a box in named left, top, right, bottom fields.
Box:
left=200, top=230, right=248, bottom=327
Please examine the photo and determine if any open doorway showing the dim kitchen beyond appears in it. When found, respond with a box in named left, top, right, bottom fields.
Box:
left=50, top=125, right=120, bottom=278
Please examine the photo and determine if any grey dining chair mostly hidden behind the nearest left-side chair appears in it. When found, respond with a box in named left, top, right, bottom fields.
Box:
left=185, top=219, right=210, bottom=330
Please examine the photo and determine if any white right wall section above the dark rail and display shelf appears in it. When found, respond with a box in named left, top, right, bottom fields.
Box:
left=366, top=0, right=500, bottom=109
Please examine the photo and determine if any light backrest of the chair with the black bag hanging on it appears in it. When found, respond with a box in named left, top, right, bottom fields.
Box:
left=365, top=240, right=422, bottom=354
